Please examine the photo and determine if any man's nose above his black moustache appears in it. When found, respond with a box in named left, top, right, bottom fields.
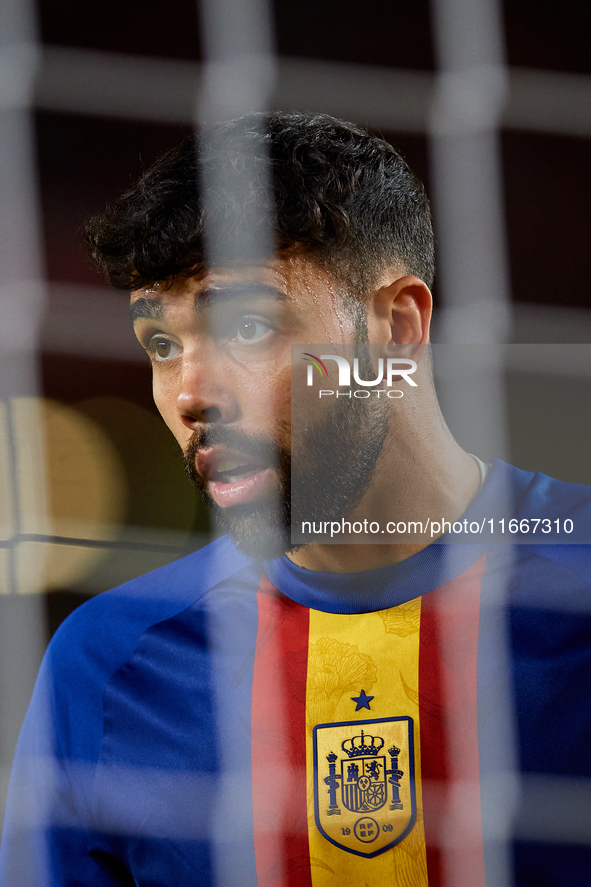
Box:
left=176, top=355, right=240, bottom=431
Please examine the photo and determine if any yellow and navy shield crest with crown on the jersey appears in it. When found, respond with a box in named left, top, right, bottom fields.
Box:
left=314, top=717, right=416, bottom=857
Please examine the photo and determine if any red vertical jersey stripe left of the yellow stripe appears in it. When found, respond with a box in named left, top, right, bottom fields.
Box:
left=251, top=578, right=312, bottom=887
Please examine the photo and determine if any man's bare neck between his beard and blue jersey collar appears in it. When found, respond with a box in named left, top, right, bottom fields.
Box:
left=288, top=410, right=480, bottom=573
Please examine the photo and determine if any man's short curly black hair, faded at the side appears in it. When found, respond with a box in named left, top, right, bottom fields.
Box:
left=85, top=112, right=434, bottom=291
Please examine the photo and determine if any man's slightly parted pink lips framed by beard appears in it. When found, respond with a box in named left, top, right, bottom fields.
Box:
left=195, top=447, right=275, bottom=508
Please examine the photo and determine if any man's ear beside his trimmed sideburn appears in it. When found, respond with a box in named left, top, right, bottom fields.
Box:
left=367, top=275, right=433, bottom=345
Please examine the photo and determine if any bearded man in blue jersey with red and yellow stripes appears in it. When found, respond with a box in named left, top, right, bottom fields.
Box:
left=2, top=114, right=591, bottom=887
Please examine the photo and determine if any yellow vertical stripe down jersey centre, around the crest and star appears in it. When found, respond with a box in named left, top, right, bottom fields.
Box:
left=306, top=598, right=428, bottom=887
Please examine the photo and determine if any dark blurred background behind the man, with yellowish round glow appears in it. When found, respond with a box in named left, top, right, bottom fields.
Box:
left=0, top=0, right=591, bottom=840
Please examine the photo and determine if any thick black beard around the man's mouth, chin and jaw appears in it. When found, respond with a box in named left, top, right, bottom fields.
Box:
left=185, top=388, right=388, bottom=560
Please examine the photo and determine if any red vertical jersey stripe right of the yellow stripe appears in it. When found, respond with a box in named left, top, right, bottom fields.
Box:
left=419, top=555, right=486, bottom=887
